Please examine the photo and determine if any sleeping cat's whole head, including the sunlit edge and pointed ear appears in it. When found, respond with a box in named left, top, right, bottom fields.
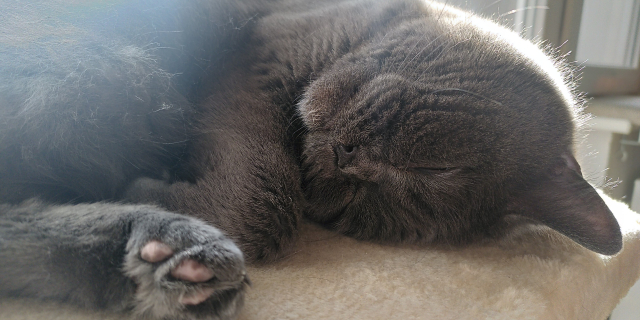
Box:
left=299, top=13, right=621, bottom=254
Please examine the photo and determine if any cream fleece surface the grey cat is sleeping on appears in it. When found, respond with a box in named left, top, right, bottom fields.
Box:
left=0, top=194, right=640, bottom=320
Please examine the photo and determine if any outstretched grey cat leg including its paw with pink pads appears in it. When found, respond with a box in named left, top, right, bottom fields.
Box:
left=0, top=201, right=248, bottom=319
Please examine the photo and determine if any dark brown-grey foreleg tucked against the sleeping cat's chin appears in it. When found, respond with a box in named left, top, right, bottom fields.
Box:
left=125, top=94, right=306, bottom=263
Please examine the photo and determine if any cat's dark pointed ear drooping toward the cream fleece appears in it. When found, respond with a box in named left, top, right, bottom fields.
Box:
left=510, top=152, right=622, bottom=255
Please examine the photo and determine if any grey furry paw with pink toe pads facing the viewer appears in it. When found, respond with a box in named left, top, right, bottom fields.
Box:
left=124, top=214, right=249, bottom=320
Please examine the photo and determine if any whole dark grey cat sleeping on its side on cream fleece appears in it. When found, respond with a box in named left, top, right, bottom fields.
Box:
left=0, top=0, right=622, bottom=319
